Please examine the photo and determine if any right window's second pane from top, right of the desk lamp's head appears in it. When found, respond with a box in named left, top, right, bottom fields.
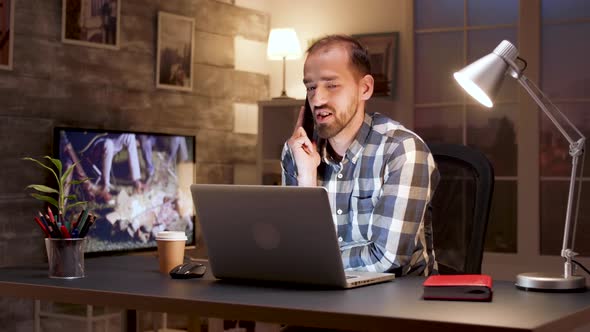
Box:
left=541, top=23, right=590, bottom=99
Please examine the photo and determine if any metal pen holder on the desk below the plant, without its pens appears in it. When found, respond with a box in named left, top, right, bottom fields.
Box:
left=45, top=238, right=86, bottom=279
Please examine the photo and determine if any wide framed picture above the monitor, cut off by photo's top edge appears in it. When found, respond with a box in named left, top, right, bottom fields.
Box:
left=61, top=0, right=121, bottom=50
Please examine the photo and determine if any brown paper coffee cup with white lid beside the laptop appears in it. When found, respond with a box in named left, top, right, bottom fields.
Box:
left=156, top=231, right=187, bottom=274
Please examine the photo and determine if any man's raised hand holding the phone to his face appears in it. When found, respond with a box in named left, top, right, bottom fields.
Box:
left=287, top=106, right=321, bottom=187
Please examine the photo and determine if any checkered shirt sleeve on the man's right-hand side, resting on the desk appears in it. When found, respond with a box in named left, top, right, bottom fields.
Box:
left=342, top=135, right=436, bottom=275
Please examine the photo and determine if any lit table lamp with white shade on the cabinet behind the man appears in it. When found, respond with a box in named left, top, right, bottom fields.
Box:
left=266, top=28, right=301, bottom=98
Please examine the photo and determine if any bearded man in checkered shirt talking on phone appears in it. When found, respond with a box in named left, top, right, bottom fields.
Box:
left=282, top=35, right=439, bottom=276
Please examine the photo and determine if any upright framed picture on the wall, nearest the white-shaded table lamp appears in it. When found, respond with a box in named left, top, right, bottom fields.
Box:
left=156, top=12, right=195, bottom=91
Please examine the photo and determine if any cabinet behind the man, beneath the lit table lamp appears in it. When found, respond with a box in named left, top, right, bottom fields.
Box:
left=256, top=98, right=305, bottom=185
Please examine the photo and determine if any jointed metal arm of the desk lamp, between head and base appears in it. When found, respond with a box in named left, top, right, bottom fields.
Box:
left=510, top=72, right=586, bottom=278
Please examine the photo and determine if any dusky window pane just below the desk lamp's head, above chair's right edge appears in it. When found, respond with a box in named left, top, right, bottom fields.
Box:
left=467, top=104, right=518, bottom=176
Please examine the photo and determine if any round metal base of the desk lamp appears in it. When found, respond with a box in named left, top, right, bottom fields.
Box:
left=516, top=272, right=586, bottom=292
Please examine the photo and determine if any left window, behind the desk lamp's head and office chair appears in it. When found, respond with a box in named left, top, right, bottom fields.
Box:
left=414, top=0, right=519, bottom=253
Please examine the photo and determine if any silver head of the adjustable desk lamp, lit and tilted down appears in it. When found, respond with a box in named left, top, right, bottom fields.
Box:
left=453, top=40, right=518, bottom=107
